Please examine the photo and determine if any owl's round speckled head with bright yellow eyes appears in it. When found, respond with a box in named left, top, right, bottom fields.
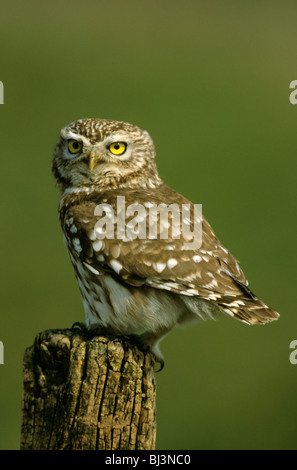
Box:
left=52, top=119, right=161, bottom=191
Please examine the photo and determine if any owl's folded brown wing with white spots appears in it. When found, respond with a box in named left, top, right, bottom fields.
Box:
left=64, top=189, right=276, bottom=323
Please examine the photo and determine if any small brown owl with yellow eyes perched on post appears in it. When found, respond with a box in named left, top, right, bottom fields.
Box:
left=52, top=119, right=279, bottom=368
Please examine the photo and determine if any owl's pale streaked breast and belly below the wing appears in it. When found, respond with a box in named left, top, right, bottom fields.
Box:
left=70, top=250, right=183, bottom=335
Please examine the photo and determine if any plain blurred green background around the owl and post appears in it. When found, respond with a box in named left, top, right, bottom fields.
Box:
left=0, top=0, right=297, bottom=449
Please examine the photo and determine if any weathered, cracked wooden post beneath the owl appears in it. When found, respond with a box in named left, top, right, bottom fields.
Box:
left=21, top=329, right=156, bottom=450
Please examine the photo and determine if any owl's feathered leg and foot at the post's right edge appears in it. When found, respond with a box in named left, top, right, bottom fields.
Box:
left=128, top=327, right=171, bottom=372
